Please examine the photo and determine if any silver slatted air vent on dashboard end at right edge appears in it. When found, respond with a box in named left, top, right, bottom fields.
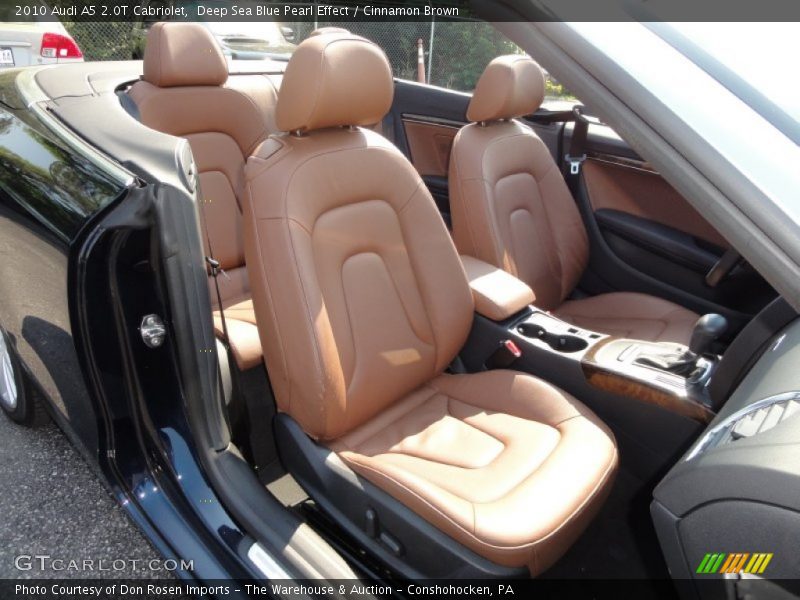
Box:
left=686, top=392, right=800, bottom=460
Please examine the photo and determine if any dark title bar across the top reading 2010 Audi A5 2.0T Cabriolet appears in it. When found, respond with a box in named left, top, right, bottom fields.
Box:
left=6, top=0, right=800, bottom=23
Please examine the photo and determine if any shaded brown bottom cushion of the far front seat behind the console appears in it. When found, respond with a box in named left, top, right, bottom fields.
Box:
left=552, top=292, right=699, bottom=346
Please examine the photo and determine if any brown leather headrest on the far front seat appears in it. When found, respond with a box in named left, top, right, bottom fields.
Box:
left=467, top=54, right=544, bottom=122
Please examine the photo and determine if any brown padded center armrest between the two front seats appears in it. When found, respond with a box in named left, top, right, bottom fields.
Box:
left=461, top=255, right=536, bottom=321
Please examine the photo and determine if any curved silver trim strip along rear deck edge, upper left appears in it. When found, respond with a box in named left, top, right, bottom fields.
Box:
left=15, top=66, right=134, bottom=187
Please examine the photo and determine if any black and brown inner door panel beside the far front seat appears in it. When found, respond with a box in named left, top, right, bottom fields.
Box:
left=564, top=125, right=775, bottom=331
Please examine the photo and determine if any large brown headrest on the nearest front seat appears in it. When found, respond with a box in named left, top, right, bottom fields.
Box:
left=275, top=31, right=393, bottom=131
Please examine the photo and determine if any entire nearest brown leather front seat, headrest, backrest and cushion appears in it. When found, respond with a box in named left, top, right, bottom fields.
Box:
left=245, top=33, right=617, bottom=574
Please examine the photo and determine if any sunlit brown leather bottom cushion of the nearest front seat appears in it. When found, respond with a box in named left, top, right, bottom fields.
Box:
left=330, top=371, right=617, bottom=575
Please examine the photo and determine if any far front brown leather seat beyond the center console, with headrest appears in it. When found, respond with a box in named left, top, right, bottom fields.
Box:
left=449, top=55, right=698, bottom=344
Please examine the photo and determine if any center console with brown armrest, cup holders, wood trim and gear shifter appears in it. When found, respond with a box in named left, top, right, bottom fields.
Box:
left=460, top=253, right=724, bottom=479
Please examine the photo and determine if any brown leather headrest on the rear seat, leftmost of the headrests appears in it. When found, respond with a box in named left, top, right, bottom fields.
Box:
left=144, top=22, right=228, bottom=87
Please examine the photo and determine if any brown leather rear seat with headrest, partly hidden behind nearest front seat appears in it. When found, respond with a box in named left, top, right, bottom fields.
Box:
left=129, top=22, right=277, bottom=370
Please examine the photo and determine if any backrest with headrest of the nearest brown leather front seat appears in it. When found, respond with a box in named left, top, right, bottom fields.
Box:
left=245, top=32, right=473, bottom=440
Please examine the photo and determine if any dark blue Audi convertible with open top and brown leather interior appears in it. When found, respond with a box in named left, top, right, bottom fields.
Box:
left=0, top=3, right=800, bottom=598
